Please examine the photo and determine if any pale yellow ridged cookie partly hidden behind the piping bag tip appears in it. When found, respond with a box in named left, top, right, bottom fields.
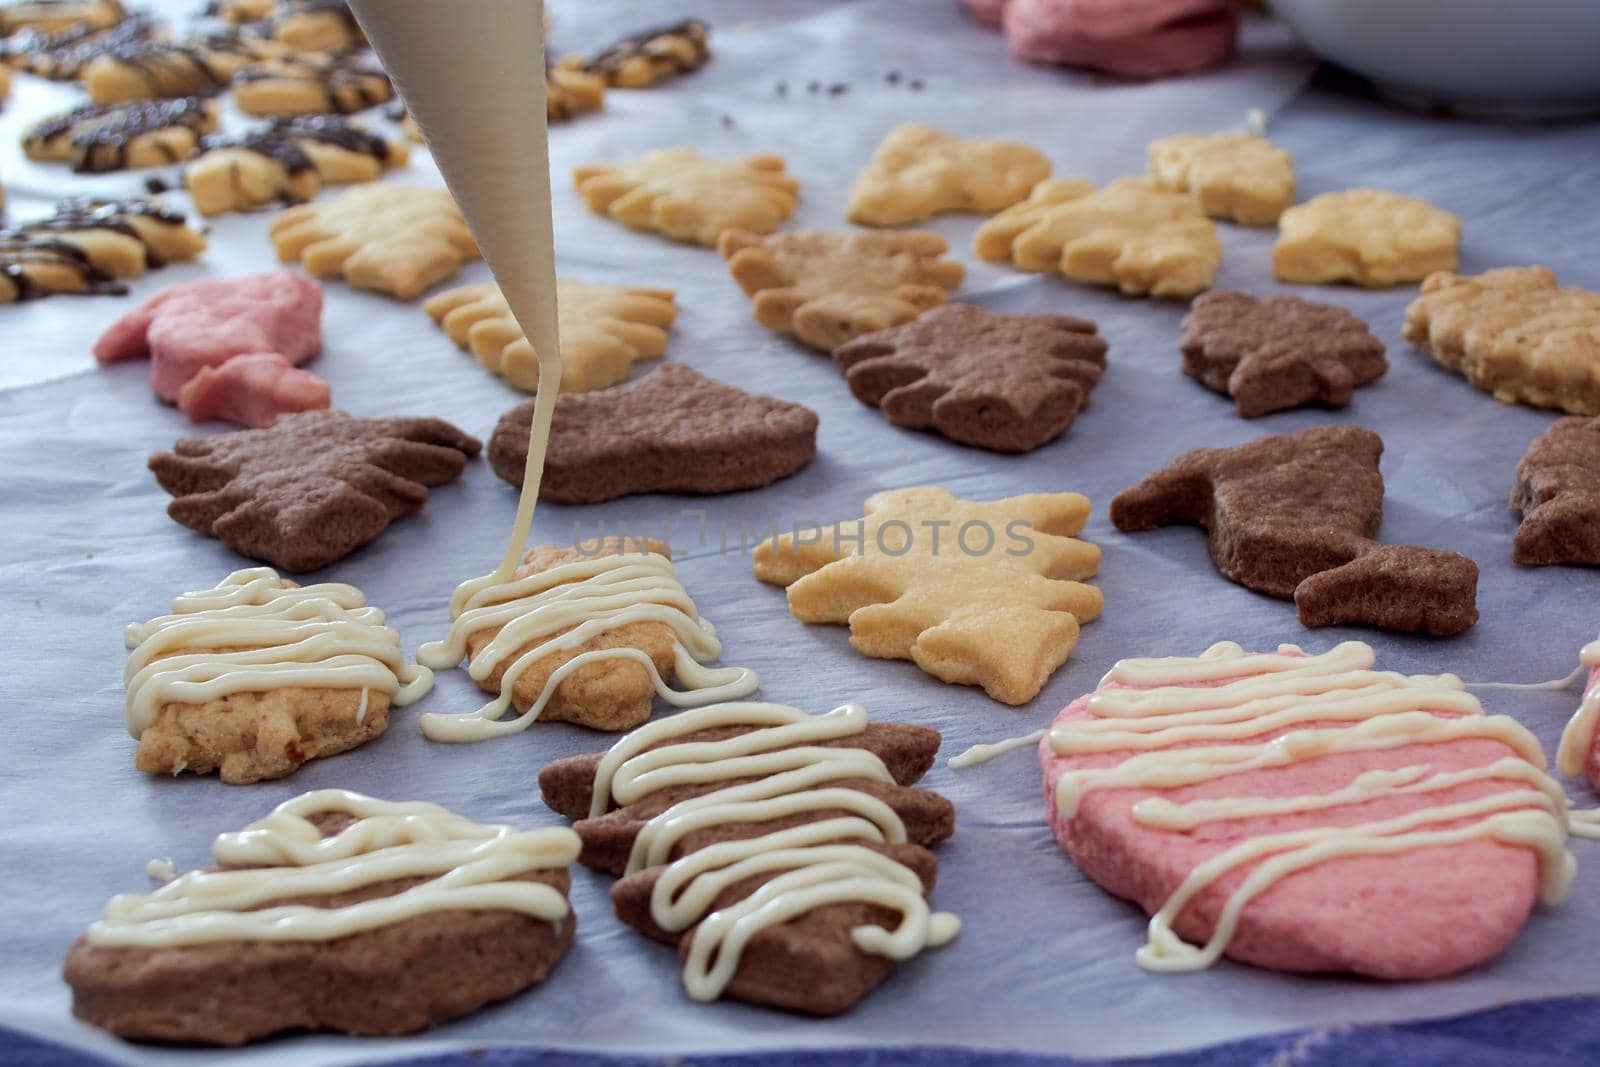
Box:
left=422, top=278, right=677, bottom=394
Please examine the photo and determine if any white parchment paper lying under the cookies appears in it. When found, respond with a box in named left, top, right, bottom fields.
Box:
left=0, top=0, right=1600, bottom=1064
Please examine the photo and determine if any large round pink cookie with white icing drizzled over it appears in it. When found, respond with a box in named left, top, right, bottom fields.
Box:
left=1040, top=641, right=1573, bottom=979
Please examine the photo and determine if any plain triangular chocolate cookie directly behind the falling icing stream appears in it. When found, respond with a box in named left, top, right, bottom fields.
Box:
left=490, top=363, right=816, bottom=504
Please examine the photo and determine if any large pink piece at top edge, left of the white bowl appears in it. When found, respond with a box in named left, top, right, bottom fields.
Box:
left=1003, top=0, right=1238, bottom=78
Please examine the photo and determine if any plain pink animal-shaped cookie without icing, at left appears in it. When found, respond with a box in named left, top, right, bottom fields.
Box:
left=94, top=270, right=328, bottom=426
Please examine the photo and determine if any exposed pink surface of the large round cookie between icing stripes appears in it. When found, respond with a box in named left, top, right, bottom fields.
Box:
left=1038, top=659, right=1539, bottom=979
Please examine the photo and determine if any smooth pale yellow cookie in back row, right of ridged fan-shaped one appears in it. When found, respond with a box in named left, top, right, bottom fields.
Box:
left=846, top=123, right=1050, bottom=226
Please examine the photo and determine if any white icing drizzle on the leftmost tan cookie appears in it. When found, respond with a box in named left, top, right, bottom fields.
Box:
left=123, top=566, right=434, bottom=737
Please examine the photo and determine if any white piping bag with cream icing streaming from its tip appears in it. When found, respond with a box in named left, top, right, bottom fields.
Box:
left=350, top=0, right=562, bottom=585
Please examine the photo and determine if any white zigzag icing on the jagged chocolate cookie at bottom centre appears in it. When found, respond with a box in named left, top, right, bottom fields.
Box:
left=590, top=702, right=960, bottom=1000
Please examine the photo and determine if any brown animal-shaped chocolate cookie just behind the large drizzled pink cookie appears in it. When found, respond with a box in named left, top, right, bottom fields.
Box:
left=1110, top=426, right=1478, bottom=637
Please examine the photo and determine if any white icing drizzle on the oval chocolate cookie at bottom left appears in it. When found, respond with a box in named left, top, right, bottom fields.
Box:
left=88, top=789, right=581, bottom=947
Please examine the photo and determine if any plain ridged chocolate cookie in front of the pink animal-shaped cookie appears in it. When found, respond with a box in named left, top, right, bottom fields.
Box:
left=149, top=411, right=482, bottom=571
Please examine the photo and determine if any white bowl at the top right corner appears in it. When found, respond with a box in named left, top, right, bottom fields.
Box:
left=1272, top=0, right=1600, bottom=110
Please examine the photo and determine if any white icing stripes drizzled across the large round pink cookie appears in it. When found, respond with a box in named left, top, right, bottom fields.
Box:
left=1049, top=641, right=1574, bottom=973
